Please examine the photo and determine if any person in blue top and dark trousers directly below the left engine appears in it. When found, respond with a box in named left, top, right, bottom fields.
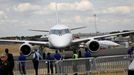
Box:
left=18, top=52, right=26, bottom=75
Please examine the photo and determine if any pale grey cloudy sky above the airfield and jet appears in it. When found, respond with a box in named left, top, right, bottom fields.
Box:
left=0, top=0, right=134, bottom=37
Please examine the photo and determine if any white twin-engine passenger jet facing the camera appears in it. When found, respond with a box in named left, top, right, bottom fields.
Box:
left=0, top=24, right=134, bottom=55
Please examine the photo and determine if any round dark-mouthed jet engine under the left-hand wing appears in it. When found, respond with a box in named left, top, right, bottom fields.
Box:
left=19, top=43, right=32, bottom=56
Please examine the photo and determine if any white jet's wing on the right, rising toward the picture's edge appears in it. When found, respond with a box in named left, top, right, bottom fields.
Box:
left=73, top=31, right=134, bottom=43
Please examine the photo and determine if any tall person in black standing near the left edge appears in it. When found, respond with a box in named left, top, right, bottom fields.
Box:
left=5, top=48, right=14, bottom=75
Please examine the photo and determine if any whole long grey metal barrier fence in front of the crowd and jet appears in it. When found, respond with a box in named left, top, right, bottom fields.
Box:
left=14, top=55, right=131, bottom=75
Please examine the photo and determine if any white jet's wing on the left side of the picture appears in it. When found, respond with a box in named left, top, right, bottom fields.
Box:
left=0, top=39, right=48, bottom=45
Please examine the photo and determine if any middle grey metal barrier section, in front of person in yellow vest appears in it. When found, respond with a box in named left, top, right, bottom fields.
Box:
left=56, top=58, right=95, bottom=74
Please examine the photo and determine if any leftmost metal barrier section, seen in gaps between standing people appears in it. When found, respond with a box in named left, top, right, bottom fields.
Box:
left=14, top=60, right=55, bottom=75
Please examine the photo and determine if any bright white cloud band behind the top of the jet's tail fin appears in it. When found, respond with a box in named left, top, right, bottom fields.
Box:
left=48, top=0, right=93, bottom=11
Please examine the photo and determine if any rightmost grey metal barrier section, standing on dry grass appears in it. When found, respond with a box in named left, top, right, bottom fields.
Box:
left=95, top=55, right=130, bottom=71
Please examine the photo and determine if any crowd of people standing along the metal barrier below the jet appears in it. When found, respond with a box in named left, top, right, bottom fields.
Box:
left=0, top=48, right=91, bottom=75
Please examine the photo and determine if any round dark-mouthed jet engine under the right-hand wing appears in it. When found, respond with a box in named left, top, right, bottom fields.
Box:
left=86, top=40, right=100, bottom=52
